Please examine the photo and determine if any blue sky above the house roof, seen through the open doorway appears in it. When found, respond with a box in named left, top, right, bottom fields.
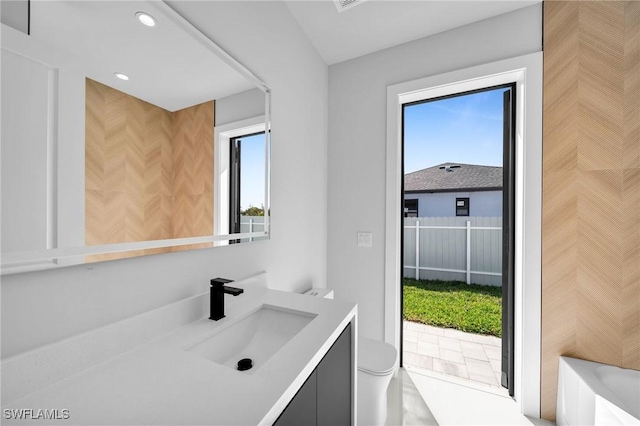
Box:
left=404, top=88, right=506, bottom=173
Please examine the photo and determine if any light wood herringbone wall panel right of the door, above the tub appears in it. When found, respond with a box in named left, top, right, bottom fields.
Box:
left=541, top=0, right=640, bottom=420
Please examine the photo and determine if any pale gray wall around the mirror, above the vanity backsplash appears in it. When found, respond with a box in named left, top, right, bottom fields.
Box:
left=0, top=1, right=328, bottom=358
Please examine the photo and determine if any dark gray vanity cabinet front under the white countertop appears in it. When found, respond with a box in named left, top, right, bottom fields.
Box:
left=274, top=324, right=353, bottom=426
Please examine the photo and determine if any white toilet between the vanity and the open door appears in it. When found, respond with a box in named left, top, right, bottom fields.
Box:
left=357, top=337, right=398, bottom=426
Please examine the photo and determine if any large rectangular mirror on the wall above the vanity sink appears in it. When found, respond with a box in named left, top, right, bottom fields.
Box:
left=0, top=0, right=270, bottom=273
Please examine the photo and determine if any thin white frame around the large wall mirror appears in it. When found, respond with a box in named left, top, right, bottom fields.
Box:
left=0, top=1, right=271, bottom=275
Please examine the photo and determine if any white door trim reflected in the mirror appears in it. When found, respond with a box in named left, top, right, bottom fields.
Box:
left=213, top=115, right=269, bottom=245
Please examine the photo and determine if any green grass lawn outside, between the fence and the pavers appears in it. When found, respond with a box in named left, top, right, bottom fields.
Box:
left=403, top=278, right=502, bottom=337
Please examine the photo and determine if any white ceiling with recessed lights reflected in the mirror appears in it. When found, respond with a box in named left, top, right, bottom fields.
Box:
left=31, top=0, right=255, bottom=111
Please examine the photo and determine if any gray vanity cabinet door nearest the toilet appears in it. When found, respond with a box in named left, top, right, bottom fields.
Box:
left=318, top=324, right=353, bottom=426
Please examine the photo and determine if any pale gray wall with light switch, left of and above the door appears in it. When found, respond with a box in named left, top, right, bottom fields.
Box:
left=327, top=5, right=542, bottom=340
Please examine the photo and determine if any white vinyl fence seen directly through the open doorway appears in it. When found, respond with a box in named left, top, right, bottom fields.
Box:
left=403, top=216, right=502, bottom=286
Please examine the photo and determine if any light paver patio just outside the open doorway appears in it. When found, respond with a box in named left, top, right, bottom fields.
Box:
left=403, top=321, right=502, bottom=388
